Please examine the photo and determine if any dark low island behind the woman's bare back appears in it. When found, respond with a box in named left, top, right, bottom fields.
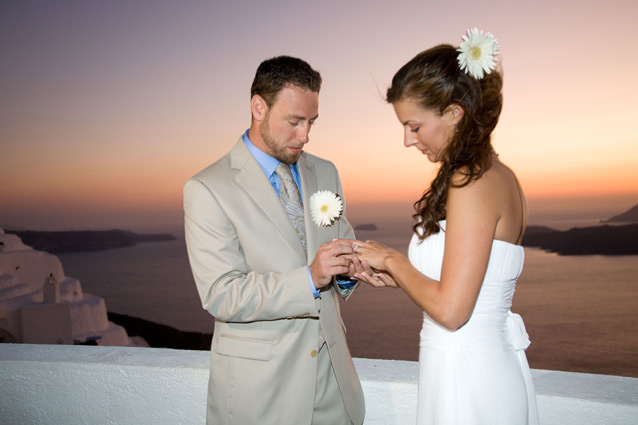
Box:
left=523, top=224, right=638, bottom=255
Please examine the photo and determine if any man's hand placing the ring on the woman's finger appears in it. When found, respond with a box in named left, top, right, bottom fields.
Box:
left=310, top=239, right=354, bottom=289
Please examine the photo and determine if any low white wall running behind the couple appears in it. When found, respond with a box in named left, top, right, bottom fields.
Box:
left=0, top=344, right=638, bottom=425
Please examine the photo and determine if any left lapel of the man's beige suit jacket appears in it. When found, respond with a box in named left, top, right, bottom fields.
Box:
left=231, top=138, right=310, bottom=263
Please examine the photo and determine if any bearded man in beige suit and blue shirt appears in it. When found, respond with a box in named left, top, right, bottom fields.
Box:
left=184, top=56, right=364, bottom=425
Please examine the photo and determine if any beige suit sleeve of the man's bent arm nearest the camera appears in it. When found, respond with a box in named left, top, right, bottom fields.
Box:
left=184, top=179, right=318, bottom=322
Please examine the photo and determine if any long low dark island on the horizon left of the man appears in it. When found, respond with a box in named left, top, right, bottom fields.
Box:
left=6, top=229, right=177, bottom=254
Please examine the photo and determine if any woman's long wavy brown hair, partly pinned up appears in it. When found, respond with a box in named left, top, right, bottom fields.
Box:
left=386, top=45, right=503, bottom=240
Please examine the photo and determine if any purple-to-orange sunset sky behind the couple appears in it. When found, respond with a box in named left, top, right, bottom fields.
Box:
left=0, top=0, right=638, bottom=230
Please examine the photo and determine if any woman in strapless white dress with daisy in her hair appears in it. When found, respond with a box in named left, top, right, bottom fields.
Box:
left=354, top=30, right=538, bottom=425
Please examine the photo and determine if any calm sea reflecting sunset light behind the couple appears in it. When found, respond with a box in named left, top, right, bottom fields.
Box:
left=58, top=209, right=638, bottom=376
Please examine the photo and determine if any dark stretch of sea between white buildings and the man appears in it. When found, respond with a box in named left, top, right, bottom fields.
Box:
left=58, top=237, right=213, bottom=332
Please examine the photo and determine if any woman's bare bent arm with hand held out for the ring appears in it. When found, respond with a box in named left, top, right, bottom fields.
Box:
left=355, top=174, right=499, bottom=330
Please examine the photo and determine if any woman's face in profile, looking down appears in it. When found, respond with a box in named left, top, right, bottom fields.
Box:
left=392, top=99, right=463, bottom=162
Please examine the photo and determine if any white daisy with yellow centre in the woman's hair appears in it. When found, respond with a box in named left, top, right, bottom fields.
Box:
left=457, top=28, right=499, bottom=80
